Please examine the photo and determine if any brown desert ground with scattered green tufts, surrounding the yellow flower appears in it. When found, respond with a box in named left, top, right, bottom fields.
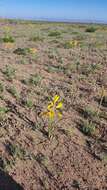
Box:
left=0, top=20, right=107, bottom=190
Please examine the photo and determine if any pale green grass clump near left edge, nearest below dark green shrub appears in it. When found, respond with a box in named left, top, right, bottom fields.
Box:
left=2, top=65, right=16, bottom=81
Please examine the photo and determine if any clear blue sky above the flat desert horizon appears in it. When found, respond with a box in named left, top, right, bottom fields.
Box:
left=0, top=0, right=107, bottom=22
